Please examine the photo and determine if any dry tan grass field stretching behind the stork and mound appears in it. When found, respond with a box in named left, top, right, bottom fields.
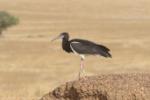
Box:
left=0, top=0, right=150, bottom=100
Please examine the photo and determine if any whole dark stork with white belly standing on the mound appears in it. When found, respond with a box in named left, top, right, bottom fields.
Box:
left=51, top=32, right=112, bottom=79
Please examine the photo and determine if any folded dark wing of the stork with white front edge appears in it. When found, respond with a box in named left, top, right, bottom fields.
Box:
left=70, top=39, right=111, bottom=57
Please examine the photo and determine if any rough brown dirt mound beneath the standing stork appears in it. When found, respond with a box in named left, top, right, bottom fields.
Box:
left=41, top=74, right=150, bottom=100
